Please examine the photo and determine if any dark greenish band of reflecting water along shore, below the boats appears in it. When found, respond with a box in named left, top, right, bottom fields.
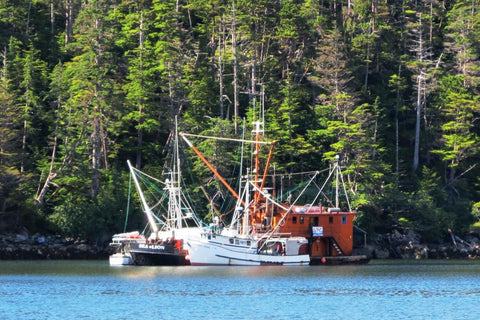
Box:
left=0, top=260, right=480, bottom=278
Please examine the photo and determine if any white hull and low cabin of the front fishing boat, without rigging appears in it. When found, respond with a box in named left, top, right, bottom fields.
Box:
left=187, top=235, right=310, bottom=266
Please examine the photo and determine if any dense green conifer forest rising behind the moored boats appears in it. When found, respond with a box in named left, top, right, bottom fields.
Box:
left=0, top=0, right=480, bottom=242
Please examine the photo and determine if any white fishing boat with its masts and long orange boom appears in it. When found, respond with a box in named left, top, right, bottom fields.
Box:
left=180, top=122, right=310, bottom=266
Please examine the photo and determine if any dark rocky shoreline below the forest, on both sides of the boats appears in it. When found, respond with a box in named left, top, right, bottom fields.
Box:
left=0, top=229, right=480, bottom=260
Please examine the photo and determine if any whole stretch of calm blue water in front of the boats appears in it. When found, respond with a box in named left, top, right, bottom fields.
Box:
left=0, top=261, right=480, bottom=320
